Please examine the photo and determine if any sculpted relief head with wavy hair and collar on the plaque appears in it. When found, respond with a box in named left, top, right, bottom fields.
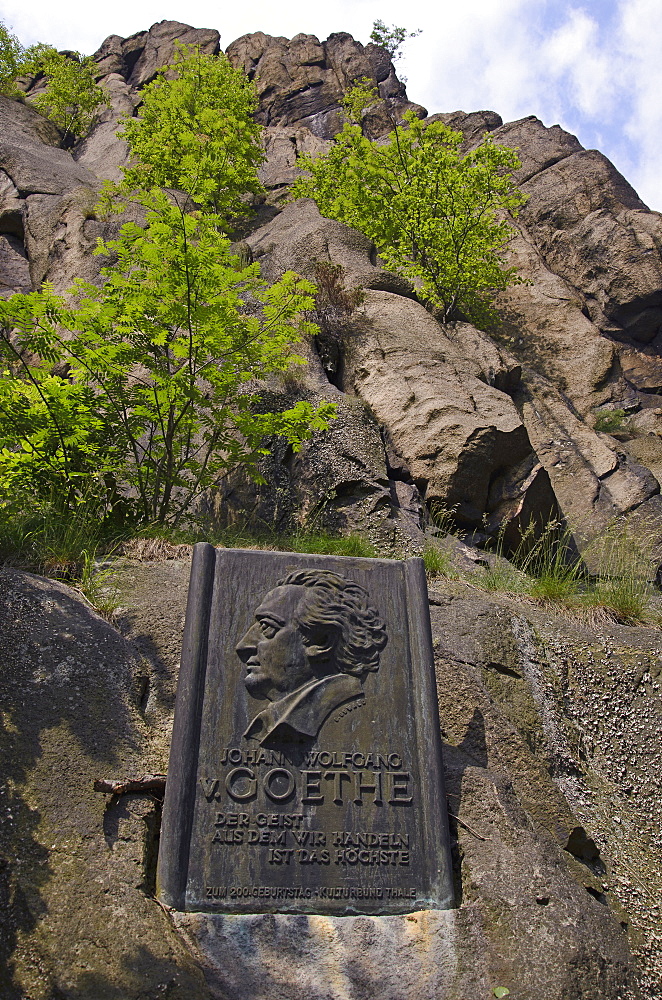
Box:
left=236, top=569, right=387, bottom=746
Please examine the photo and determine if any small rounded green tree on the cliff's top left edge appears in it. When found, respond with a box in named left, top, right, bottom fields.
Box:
left=29, top=45, right=108, bottom=146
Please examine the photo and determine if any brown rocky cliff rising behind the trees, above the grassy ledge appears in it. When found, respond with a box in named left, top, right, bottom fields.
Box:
left=5, top=21, right=662, bottom=548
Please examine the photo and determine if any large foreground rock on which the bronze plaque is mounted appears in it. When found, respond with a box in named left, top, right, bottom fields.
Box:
left=0, top=552, right=662, bottom=1000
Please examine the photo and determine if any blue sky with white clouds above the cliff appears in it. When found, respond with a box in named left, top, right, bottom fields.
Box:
left=5, top=0, right=662, bottom=210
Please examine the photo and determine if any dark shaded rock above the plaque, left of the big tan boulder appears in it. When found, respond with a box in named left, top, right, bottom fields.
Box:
left=211, top=376, right=427, bottom=553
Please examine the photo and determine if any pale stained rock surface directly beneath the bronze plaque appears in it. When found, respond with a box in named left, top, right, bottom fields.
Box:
left=173, top=910, right=466, bottom=1000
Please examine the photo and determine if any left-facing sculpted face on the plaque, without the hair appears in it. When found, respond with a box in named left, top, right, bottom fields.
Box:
left=236, top=584, right=324, bottom=701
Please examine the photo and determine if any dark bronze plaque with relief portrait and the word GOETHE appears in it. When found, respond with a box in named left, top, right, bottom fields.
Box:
left=158, top=543, right=452, bottom=916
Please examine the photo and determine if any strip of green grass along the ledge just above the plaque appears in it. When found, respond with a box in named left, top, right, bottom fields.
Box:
left=0, top=504, right=662, bottom=627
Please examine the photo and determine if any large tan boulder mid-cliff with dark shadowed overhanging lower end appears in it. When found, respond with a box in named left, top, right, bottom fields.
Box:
left=344, top=292, right=551, bottom=527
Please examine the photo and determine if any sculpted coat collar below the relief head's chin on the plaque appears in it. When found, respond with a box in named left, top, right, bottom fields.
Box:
left=244, top=674, right=363, bottom=746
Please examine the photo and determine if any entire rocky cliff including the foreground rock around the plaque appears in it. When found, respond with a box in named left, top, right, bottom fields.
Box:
left=0, top=22, right=662, bottom=1000
